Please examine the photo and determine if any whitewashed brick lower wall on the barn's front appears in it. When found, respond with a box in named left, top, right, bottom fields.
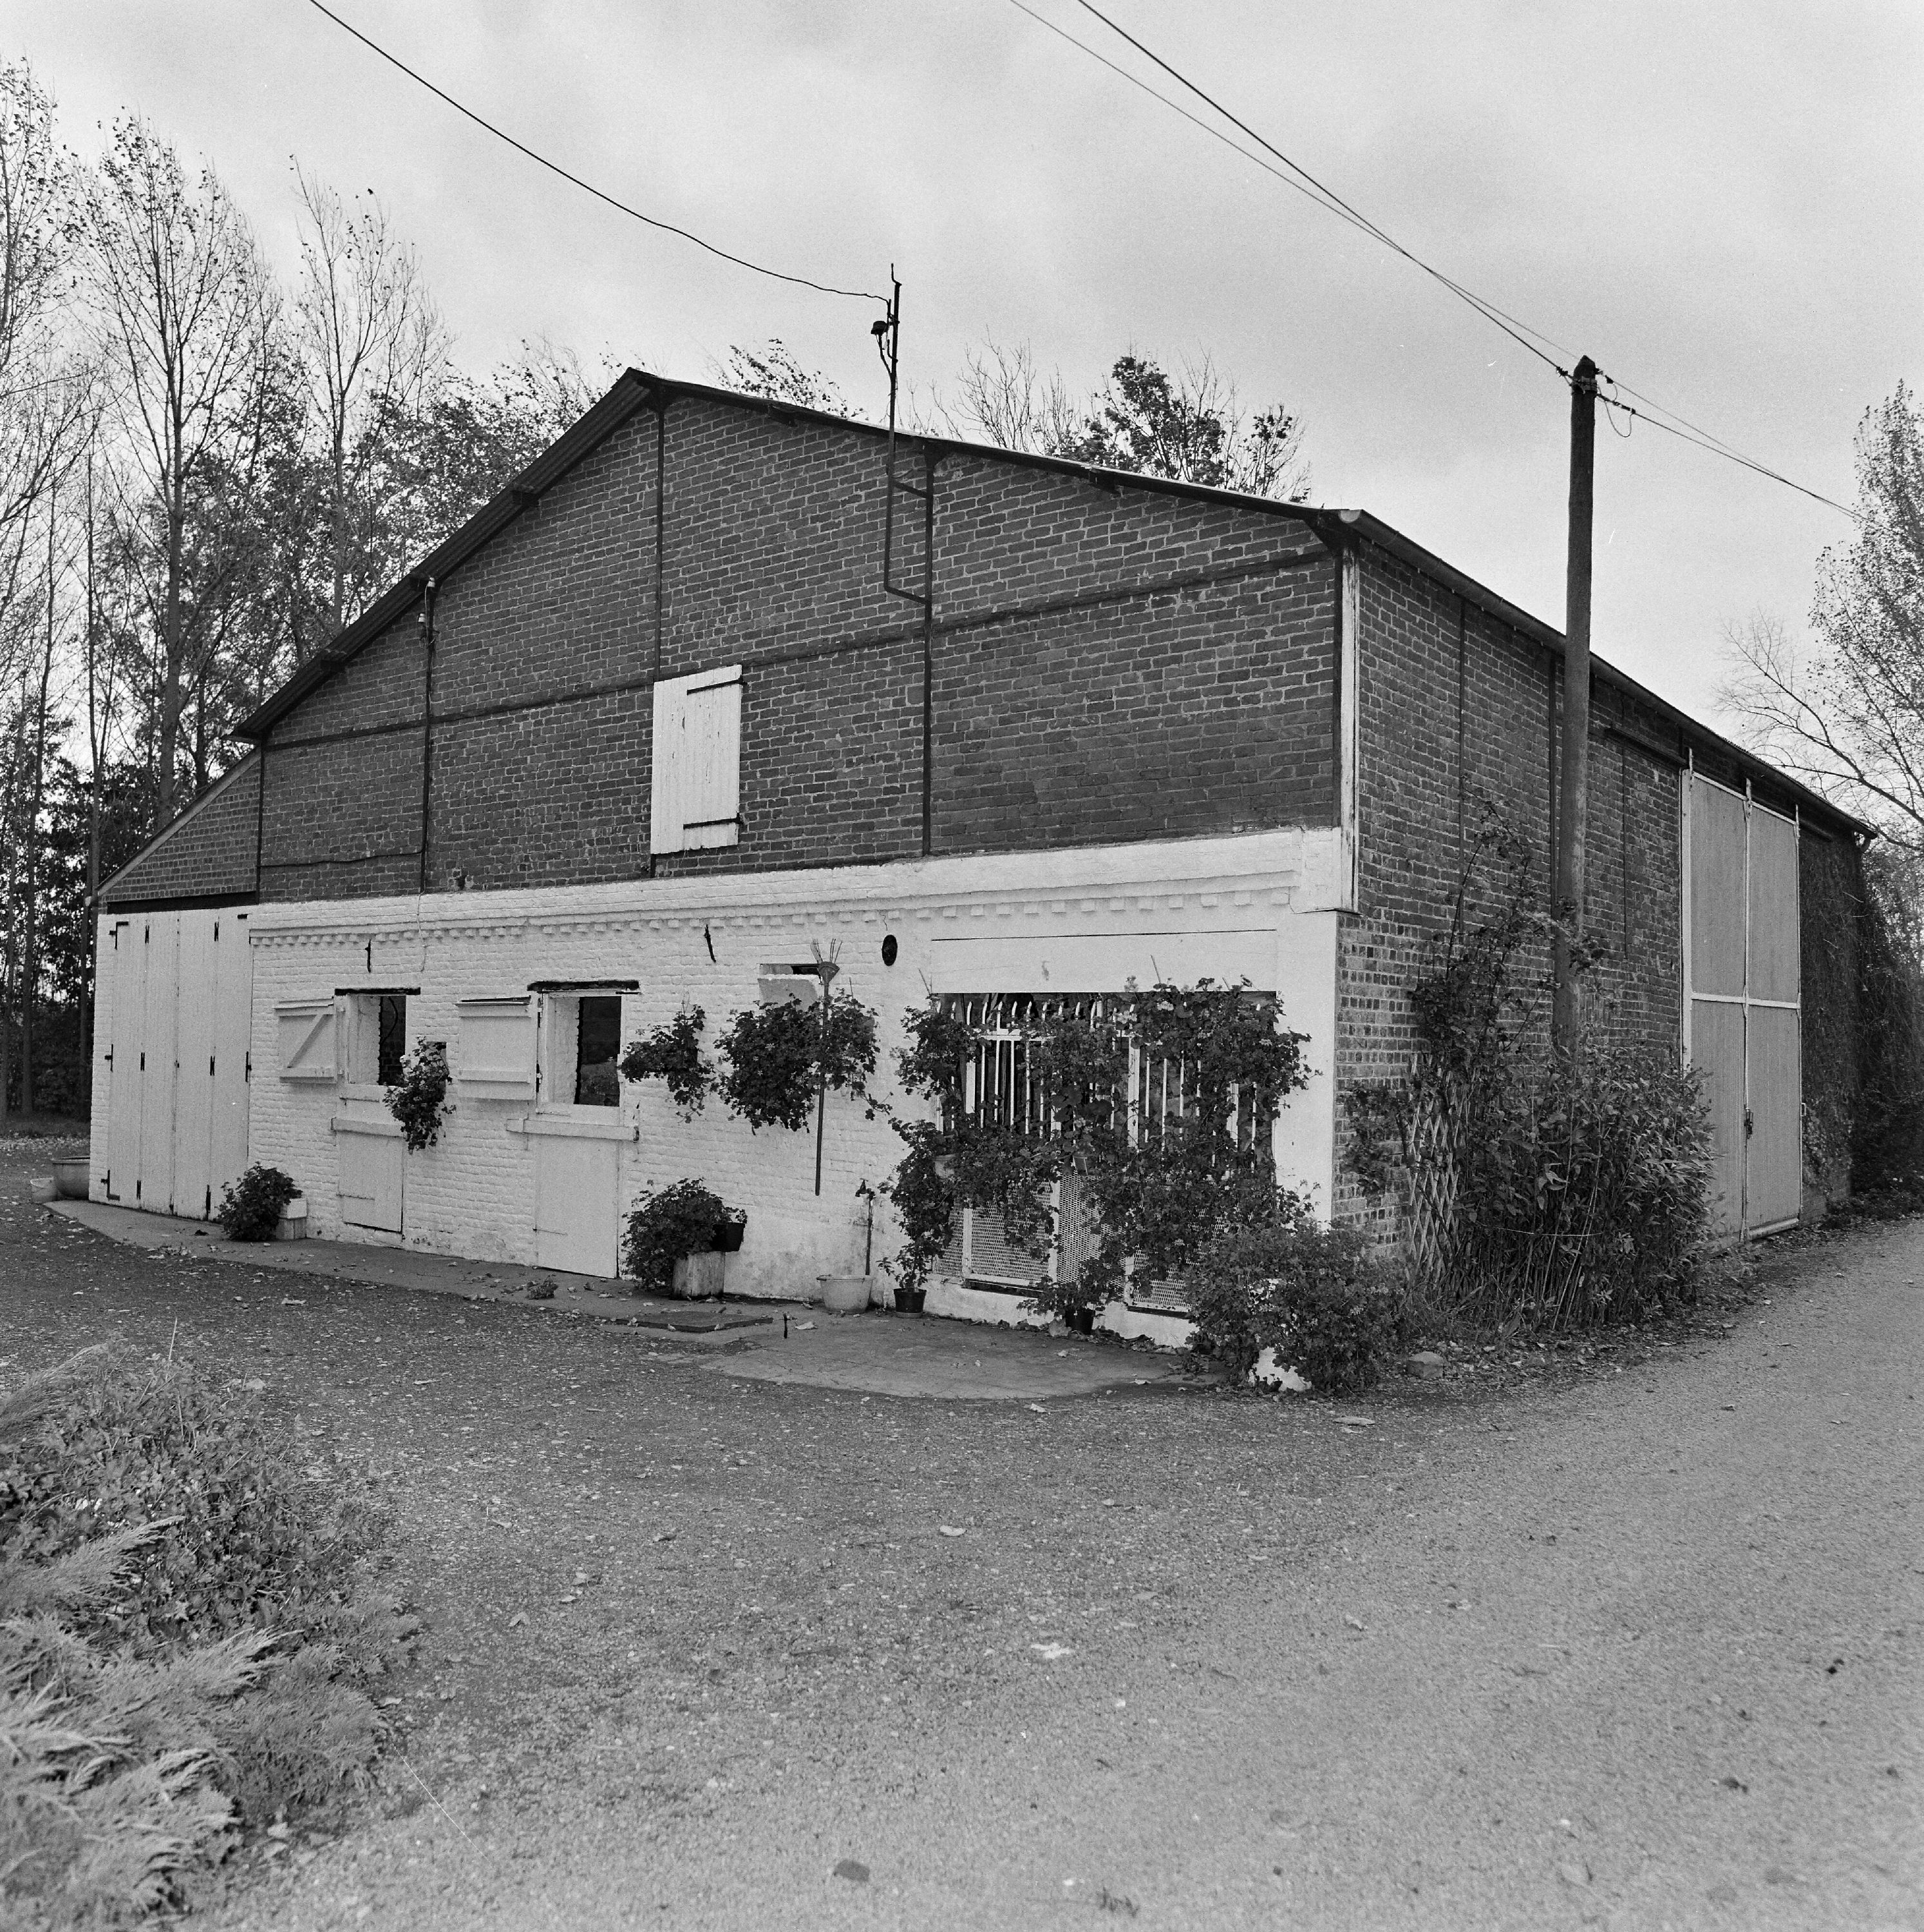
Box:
left=249, top=831, right=1339, bottom=1314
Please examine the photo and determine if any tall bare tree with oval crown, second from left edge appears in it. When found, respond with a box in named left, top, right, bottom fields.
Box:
left=83, top=118, right=278, bottom=823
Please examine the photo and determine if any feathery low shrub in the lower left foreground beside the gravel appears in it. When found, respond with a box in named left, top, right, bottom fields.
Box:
left=0, top=1349, right=411, bottom=1924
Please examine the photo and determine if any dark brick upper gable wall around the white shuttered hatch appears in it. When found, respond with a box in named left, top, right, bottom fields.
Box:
left=244, top=398, right=1335, bottom=900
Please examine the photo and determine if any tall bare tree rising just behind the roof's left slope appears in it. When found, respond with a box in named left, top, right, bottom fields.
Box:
left=294, top=166, right=448, bottom=632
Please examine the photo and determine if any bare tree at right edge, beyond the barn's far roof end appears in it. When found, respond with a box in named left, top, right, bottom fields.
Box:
left=1721, top=384, right=1924, bottom=856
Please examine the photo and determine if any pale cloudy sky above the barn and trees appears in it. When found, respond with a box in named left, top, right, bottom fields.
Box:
left=0, top=0, right=1924, bottom=730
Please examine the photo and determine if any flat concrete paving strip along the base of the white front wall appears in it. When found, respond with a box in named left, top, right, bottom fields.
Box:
left=46, top=1200, right=1184, bottom=1403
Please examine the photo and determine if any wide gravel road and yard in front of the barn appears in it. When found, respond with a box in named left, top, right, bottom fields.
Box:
left=0, top=1150, right=1924, bottom=1932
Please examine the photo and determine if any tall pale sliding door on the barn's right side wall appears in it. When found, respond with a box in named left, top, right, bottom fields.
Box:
left=1684, top=773, right=1804, bottom=1236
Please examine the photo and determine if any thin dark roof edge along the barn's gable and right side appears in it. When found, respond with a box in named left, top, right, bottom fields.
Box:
left=238, top=369, right=1876, bottom=838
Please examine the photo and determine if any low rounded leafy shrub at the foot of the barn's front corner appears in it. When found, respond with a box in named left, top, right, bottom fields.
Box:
left=1190, top=1194, right=1404, bottom=1395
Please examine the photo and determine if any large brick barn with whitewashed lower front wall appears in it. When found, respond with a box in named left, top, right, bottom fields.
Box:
left=93, top=371, right=1864, bottom=1329
